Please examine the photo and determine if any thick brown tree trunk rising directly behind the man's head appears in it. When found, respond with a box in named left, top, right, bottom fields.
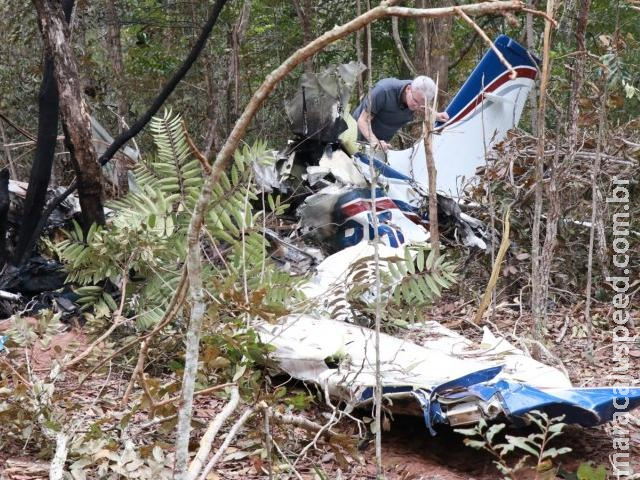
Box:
left=413, top=0, right=453, bottom=105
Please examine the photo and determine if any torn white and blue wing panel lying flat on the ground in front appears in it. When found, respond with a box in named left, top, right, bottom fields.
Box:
left=257, top=315, right=640, bottom=433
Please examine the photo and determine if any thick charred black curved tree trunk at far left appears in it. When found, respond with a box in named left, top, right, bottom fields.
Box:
left=12, top=0, right=74, bottom=265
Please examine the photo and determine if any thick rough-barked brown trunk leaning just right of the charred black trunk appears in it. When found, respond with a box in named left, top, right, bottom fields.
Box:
left=33, top=0, right=104, bottom=229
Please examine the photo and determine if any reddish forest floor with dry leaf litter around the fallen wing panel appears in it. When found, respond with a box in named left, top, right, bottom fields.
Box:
left=0, top=301, right=640, bottom=480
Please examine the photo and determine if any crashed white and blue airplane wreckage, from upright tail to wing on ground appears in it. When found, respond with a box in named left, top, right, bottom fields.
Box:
left=0, top=35, right=640, bottom=433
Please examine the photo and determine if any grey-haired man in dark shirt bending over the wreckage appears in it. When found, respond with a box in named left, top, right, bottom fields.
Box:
left=352, top=76, right=449, bottom=151
